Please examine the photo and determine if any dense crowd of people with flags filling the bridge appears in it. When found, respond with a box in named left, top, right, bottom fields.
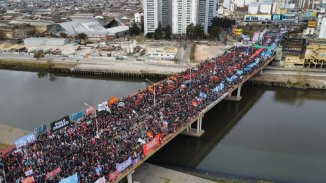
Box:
left=0, top=30, right=280, bottom=183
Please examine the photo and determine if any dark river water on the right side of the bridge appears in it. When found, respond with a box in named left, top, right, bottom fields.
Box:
left=150, top=87, right=326, bottom=182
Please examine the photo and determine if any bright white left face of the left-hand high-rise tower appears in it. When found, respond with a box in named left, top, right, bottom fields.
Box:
left=143, top=0, right=160, bottom=35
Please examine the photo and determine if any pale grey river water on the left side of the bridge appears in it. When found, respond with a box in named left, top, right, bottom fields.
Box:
left=0, top=70, right=146, bottom=130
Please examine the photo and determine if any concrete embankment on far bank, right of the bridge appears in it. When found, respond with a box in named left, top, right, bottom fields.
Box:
left=249, top=67, right=326, bottom=89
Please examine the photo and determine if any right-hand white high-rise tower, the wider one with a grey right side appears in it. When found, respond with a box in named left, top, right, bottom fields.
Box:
left=172, top=0, right=217, bottom=34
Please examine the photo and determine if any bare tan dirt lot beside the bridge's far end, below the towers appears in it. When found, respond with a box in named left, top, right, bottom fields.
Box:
left=195, top=44, right=230, bottom=63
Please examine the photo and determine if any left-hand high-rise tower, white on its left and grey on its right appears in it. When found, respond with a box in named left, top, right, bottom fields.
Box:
left=143, top=0, right=172, bottom=35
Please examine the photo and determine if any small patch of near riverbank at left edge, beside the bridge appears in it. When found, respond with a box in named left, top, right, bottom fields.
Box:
left=0, top=123, right=31, bottom=151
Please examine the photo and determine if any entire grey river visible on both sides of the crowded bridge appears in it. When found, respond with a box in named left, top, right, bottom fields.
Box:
left=0, top=70, right=326, bottom=182
